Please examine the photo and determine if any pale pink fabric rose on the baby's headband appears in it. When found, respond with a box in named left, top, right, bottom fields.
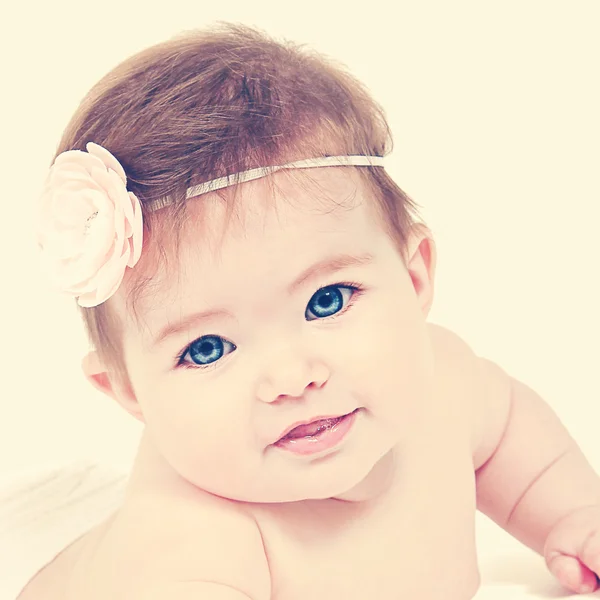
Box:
left=37, top=142, right=142, bottom=307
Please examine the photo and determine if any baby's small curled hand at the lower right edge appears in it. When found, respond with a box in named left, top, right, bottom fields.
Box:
left=544, top=505, right=600, bottom=594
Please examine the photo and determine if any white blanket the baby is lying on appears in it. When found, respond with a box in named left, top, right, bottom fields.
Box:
left=0, top=461, right=600, bottom=600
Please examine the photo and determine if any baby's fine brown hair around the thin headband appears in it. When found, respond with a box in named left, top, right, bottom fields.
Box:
left=56, top=24, right=420, bottom=392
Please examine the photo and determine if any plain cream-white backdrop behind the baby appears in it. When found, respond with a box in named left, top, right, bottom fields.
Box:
left=0, top=0, right=600, bottom=596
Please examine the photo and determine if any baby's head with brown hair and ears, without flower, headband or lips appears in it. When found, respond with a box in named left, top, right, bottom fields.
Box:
left=39, top=26, right=435, bottom=502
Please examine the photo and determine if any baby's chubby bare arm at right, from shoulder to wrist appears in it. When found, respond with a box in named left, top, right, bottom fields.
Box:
left=473, top=355, right=600, bottom=554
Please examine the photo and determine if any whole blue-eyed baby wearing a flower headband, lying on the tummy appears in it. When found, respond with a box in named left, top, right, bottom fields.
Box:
left=30, top=25, right=600, bottom=600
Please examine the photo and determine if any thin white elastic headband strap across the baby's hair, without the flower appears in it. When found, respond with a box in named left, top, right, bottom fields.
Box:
left=146, top=155, right=384, bottom=212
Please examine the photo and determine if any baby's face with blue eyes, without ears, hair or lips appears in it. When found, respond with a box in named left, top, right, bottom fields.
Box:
left=117, top=168, right=432, bottom=502
